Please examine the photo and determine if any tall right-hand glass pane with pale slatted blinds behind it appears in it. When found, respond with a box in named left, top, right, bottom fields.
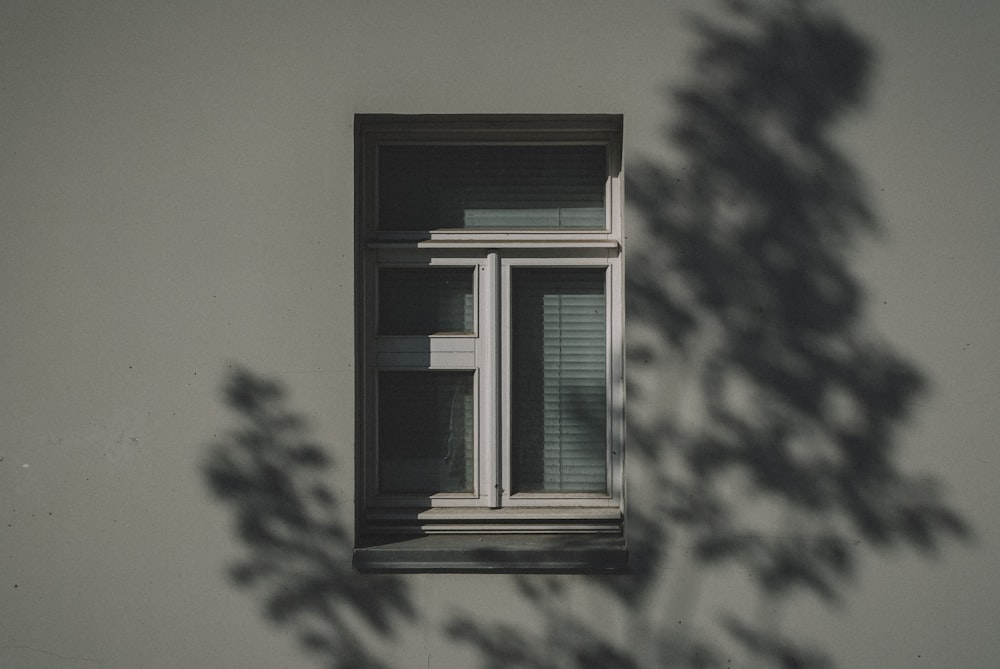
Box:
left=511, top=268, right=607, bottom=492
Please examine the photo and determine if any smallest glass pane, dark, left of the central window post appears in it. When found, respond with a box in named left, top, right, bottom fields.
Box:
left=378, top=267, right=475, bottom=335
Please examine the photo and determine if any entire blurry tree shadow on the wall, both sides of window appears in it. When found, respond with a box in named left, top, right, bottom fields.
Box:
left=204, top=0, right=969, bottom=669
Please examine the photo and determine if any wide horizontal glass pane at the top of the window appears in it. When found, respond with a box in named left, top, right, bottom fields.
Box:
left=378, top=145, right=608, bottom=231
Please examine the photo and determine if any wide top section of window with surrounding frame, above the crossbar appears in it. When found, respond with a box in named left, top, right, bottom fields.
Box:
left=357, top=115, right=622, bottom=243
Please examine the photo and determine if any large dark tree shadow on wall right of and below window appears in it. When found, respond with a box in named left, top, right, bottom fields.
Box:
left=449, top=0, right=971, bottom=669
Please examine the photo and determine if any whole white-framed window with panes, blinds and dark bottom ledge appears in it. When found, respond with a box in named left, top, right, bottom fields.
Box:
left=355, top=115, right=624, bottom=571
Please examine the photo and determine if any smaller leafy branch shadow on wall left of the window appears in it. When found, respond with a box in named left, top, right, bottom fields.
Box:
left=202, top=368, right=415, bottom=669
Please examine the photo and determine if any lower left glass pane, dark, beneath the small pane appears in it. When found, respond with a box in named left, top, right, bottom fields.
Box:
left=378, top=371, right=474, bottom=494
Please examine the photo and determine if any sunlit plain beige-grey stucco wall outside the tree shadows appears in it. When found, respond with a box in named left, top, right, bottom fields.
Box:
left=0, top=1, right=1000, bottom=669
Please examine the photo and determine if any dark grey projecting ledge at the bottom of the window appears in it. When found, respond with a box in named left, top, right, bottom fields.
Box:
left=354, top=534, right=628, bottom=573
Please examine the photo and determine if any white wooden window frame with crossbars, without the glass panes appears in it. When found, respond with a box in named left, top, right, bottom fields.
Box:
left=356, top=115, right=625, bottom=533
